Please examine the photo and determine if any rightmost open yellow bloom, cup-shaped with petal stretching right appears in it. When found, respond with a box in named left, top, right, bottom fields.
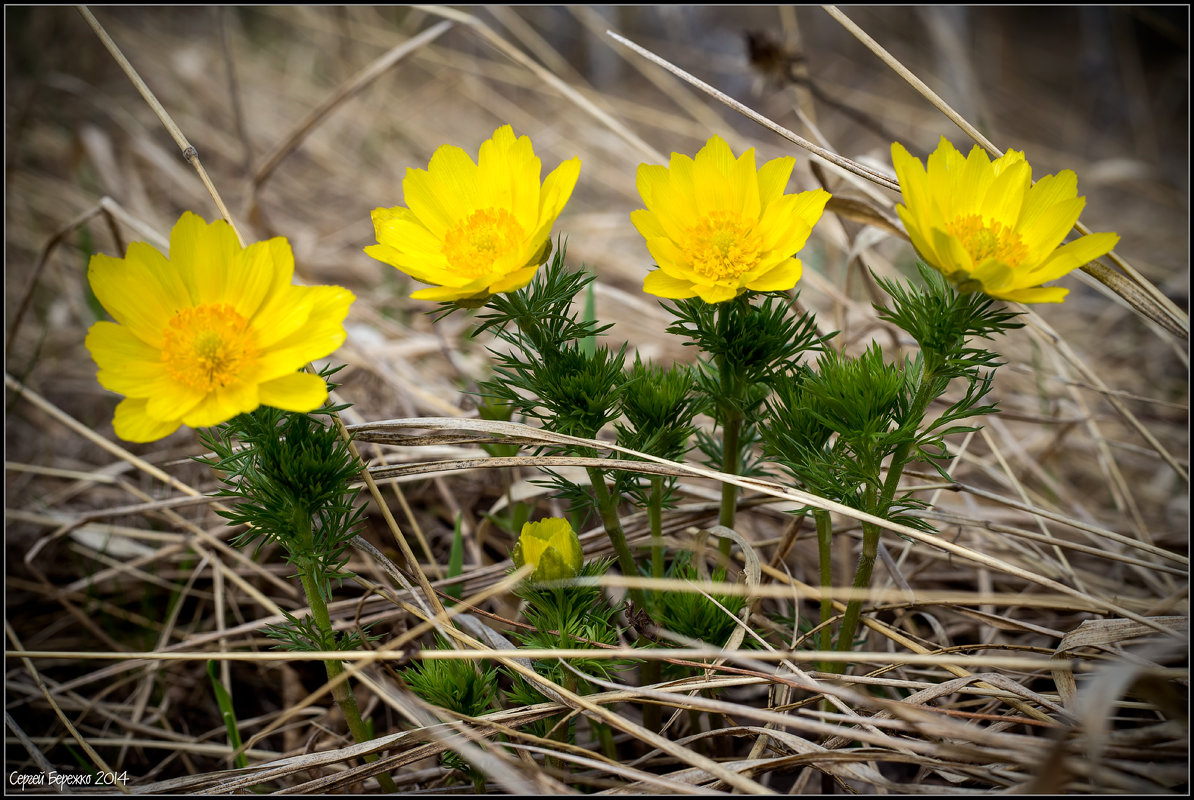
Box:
left=892, top=137, right=1119, bottom=303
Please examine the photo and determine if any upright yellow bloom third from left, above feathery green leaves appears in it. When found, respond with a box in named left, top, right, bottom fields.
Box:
left=630, top=136, right=829, bottom=303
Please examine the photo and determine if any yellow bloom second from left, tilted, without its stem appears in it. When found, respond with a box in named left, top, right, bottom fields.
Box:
left=365, top=125, right=580, bottom=306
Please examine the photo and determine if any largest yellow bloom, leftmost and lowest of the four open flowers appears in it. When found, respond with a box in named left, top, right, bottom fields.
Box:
left=87, top=211, right=353, bottom=442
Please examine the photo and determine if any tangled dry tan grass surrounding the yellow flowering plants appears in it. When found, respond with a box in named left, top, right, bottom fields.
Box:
left=5, top=7, right=1189, bottom=794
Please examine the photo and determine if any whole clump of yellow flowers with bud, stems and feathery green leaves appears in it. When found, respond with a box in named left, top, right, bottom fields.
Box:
left=77, top=109, right=1118, bottom=778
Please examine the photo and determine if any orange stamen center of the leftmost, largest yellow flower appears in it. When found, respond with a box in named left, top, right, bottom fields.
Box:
left=161, top=303, right=258, bottom=392
